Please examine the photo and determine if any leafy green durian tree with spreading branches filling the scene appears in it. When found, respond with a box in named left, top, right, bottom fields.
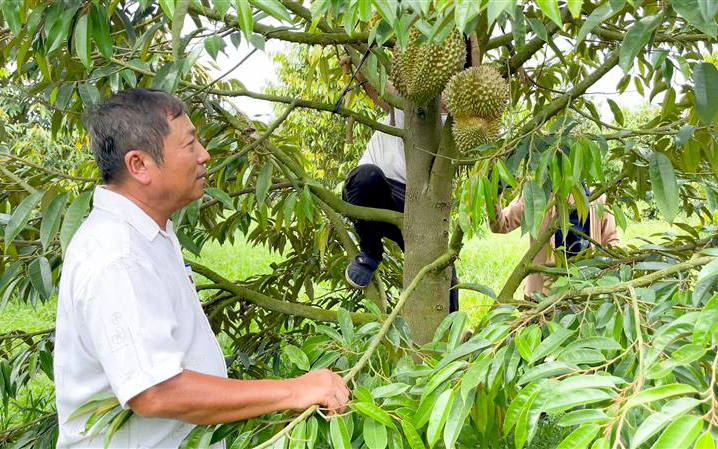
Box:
left=0, top=0, right=718, bottom=449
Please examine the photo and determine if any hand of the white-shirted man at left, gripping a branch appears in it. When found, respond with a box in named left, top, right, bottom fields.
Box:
left=288, top=369, right=349, bottom=415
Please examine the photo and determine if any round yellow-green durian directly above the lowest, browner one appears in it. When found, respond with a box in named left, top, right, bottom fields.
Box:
left=442, top=65, right=509, bottom=119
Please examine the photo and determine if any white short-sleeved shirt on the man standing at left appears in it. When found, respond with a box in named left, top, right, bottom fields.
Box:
left=54, top=187, right=227, bottom=448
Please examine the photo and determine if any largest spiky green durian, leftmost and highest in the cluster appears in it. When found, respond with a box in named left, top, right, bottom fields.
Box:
left=390, top=28, right=466, bottom=105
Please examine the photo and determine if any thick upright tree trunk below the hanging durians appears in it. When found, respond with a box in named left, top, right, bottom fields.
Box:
left=403, top=97, right=453, bottom=344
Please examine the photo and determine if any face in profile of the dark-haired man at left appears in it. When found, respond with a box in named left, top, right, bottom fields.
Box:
left=156, top=114, right=209, bottom=210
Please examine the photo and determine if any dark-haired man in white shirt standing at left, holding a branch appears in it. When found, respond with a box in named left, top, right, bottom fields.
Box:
left=55, top=89, right=349, bottom=448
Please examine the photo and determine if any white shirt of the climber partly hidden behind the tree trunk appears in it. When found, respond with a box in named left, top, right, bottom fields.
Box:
left=359, top=109, right=406, bottom=184
